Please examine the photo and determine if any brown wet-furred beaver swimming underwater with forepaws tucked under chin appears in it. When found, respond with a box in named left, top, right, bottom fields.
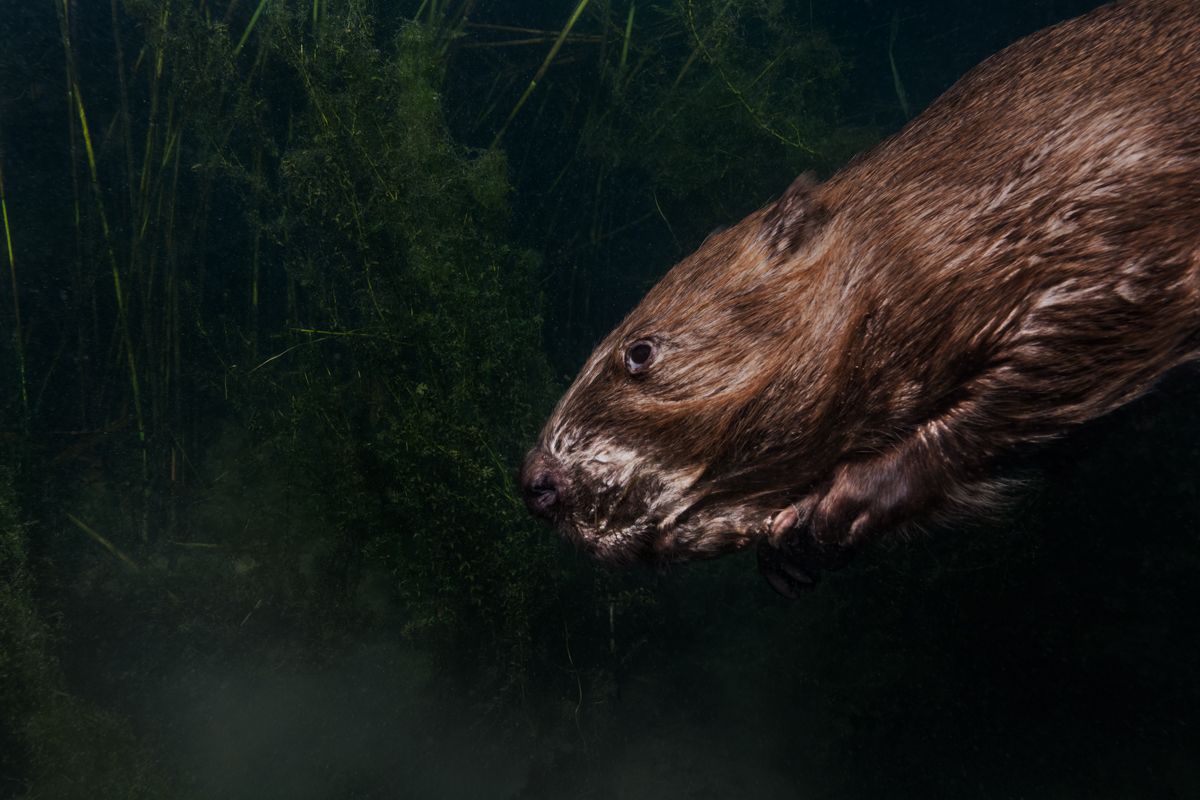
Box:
left=521, top=0, right=1200, bottom=595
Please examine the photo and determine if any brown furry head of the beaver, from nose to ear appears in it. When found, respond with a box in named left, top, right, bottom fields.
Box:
left=522, top=176, right=827, bottom=563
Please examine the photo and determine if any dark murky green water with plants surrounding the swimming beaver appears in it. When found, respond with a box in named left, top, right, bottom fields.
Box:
left=0, top=0, right=1200, bottom=800
